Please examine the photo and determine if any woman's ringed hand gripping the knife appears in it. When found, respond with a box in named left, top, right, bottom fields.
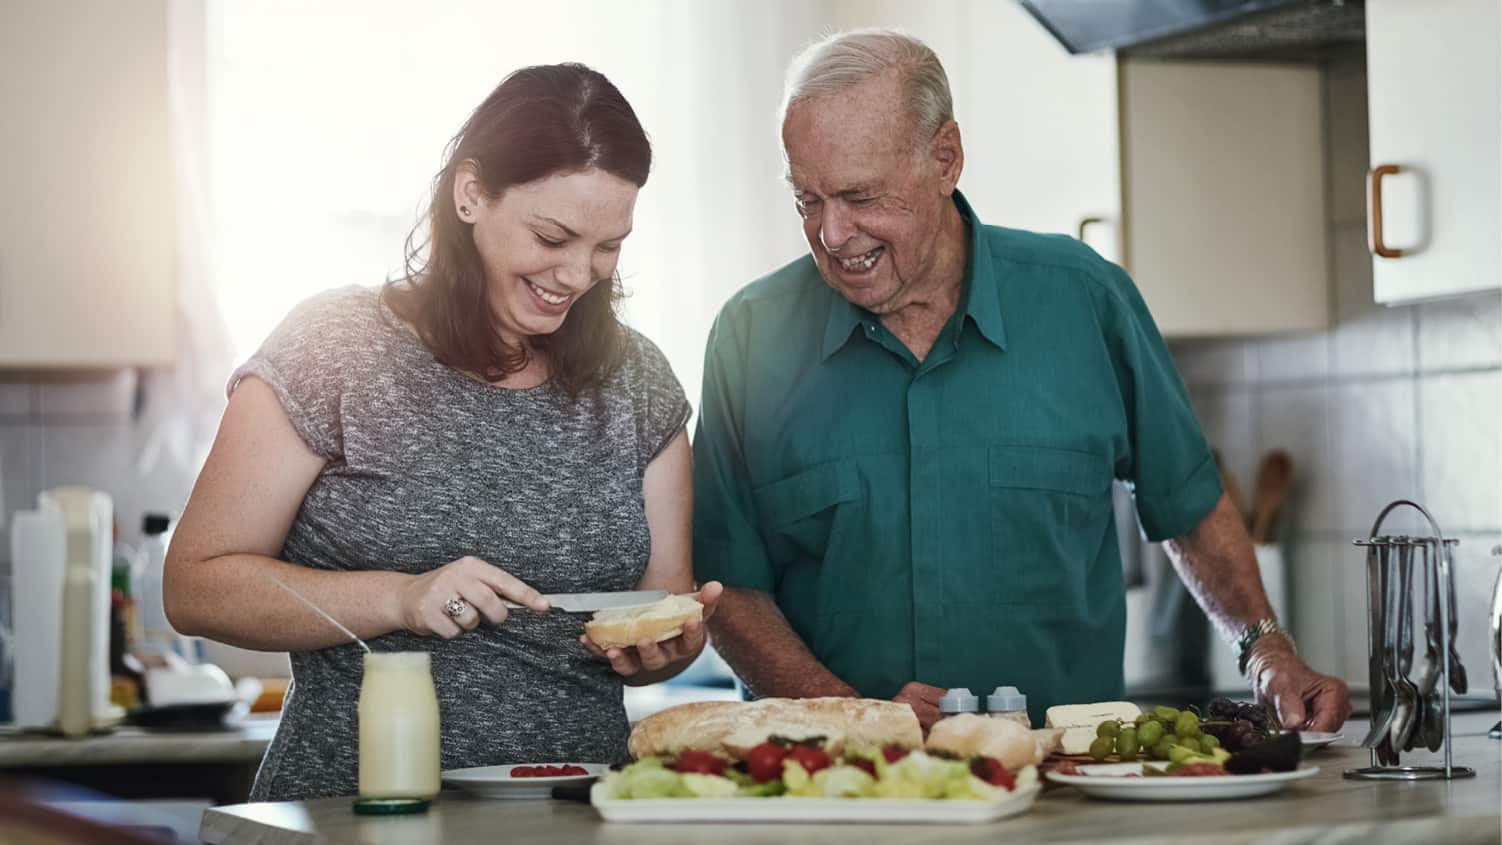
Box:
left=397, top=557, right=548, bottom=639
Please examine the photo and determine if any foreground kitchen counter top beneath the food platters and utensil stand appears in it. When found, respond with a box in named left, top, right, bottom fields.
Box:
left=198, top=711, right=1502, bottom=845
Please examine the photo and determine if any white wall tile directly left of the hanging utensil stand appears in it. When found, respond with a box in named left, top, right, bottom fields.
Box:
left=1284, top=540, right=1361, bottom=674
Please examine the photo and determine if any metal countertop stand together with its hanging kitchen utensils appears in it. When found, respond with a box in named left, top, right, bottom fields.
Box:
left=1344, top=500, right=1476, bottom=780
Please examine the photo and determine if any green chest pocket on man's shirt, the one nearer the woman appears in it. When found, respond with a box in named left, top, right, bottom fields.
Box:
left=753, top=461, right=862, bottom=564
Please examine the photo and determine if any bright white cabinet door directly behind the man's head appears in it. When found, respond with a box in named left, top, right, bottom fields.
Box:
left=951, top=2, right=1120, bottom=261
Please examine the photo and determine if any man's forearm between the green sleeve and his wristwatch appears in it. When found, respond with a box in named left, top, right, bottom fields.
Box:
left=1163, top=495, right=1274, bottom=641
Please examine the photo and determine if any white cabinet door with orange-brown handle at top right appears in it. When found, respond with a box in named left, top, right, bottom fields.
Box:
left=1367, top=0, right=1502, bottom=303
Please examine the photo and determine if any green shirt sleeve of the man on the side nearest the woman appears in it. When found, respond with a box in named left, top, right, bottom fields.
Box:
left=694, top=306, right=778, bottom=593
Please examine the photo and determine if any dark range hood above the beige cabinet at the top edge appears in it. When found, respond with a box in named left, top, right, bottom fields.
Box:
left=1021, top=0, right=1365, bottom=60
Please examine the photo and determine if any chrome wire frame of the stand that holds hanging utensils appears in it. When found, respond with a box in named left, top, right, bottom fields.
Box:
left=1344, top=498, right=1476, bottom=780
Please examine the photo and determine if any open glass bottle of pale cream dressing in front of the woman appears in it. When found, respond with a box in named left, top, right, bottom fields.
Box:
left=357, top=651, right=440, bottom=812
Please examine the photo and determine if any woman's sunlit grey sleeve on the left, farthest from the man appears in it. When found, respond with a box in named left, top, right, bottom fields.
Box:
left=227, top=287, right=379, bottom=461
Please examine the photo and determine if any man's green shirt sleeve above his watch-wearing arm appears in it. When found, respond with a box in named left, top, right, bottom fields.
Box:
left=1105, top=266, right=1223, bottom=542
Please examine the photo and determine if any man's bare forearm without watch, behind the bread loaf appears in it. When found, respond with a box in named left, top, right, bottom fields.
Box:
left=709, top=588, right=858, bottom=698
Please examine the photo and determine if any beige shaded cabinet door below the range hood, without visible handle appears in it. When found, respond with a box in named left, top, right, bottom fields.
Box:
left=1120, top=60, right=1329, bottom=336
